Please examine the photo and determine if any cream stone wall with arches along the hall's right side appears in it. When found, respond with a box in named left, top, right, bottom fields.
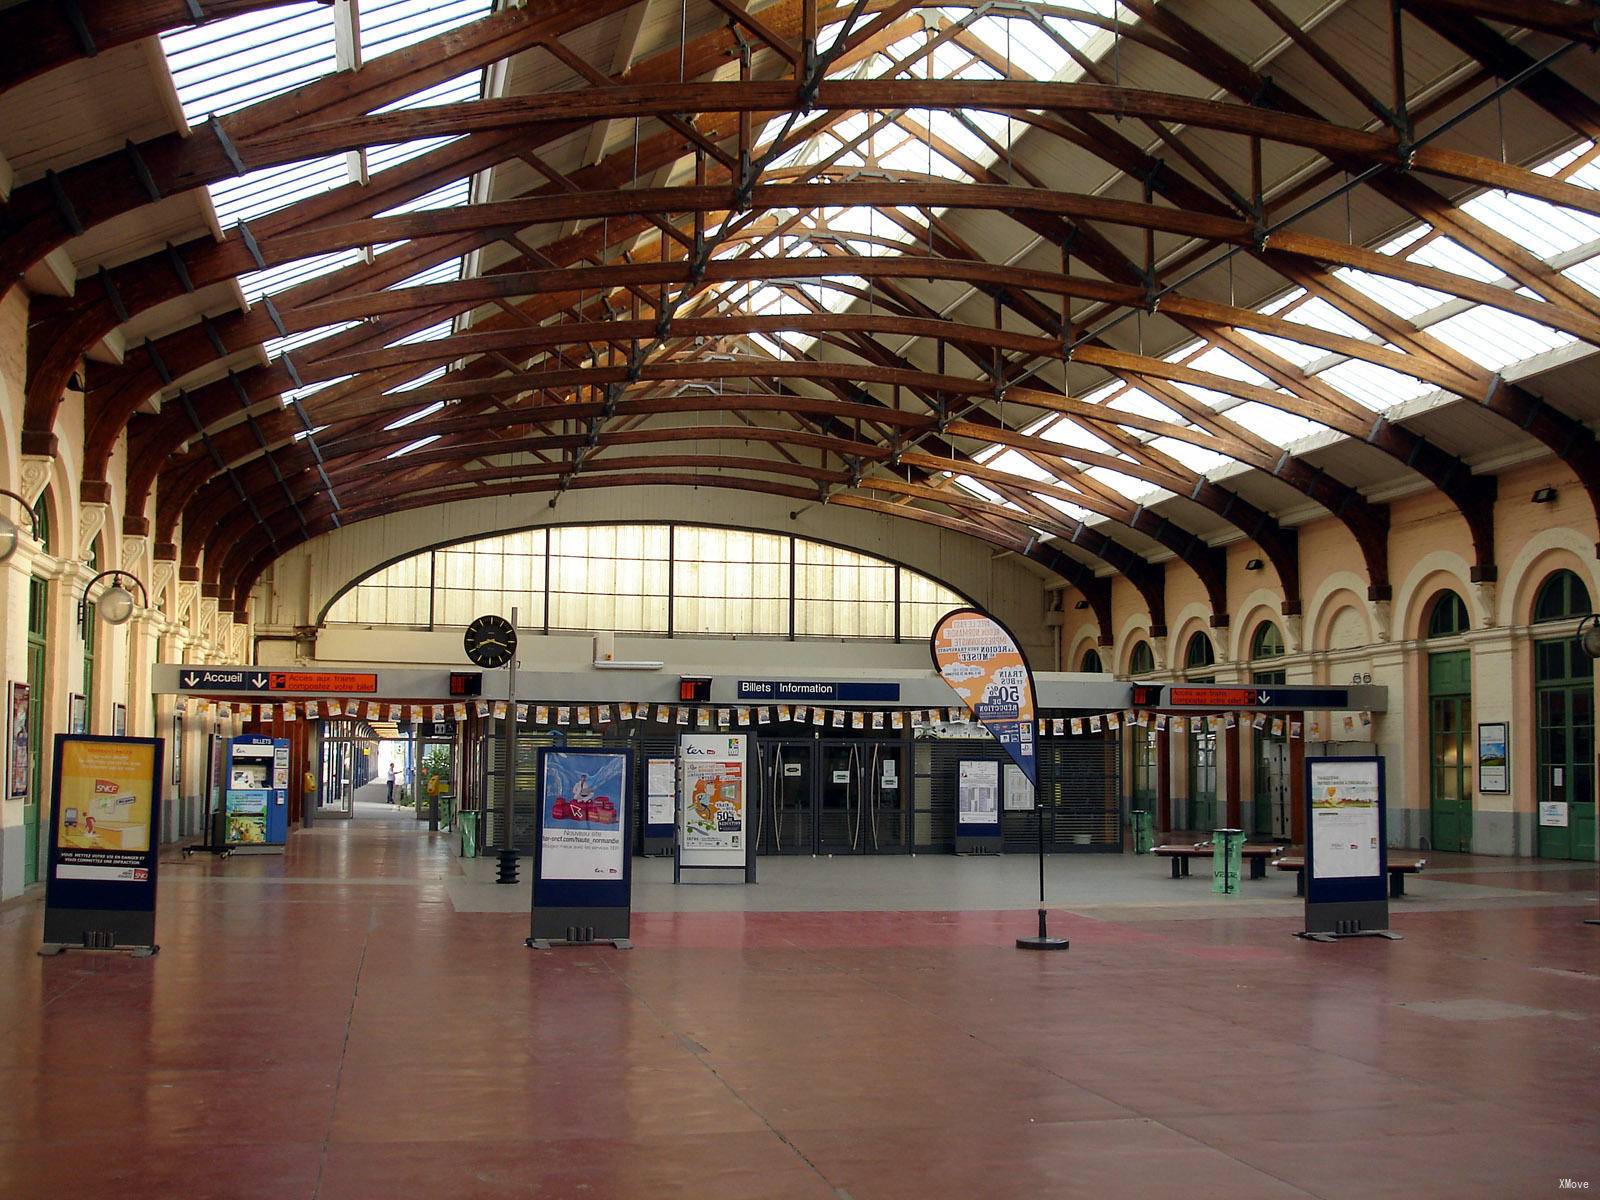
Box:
left=1061, top=458, right=1600, bottom=854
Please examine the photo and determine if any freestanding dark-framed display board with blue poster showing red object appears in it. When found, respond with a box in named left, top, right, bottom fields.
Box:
left=528, top=746, right=632, bottom=949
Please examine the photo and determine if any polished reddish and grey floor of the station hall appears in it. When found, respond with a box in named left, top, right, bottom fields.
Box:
left=0, top=805, right=1600, bottom=1200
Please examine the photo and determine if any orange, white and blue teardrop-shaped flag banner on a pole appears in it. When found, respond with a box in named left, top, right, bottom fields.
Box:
left=928, top=608, right=1038, bottom=789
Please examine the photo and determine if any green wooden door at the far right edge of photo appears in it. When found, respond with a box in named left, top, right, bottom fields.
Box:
left=1533, top=638, right=1595, bottom=861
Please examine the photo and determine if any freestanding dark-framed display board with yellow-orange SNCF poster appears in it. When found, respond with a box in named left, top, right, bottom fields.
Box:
left=42, top=733, right=162, bottom=954
